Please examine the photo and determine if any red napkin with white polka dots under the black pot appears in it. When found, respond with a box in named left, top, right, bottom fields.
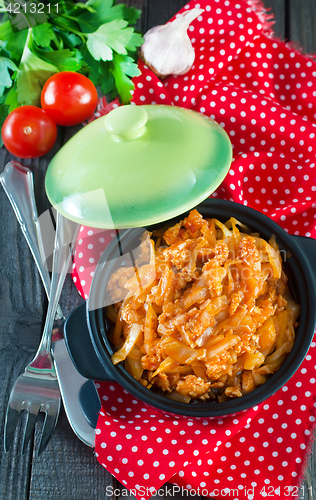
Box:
left=73, top=0, right=316, bottom=500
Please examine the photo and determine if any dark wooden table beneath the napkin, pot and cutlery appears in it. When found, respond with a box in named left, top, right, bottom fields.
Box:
left=0, top=0, right=316, bottom=500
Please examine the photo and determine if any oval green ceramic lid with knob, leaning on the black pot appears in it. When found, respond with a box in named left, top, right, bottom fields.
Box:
left=45, top=105, right=232, bottom=229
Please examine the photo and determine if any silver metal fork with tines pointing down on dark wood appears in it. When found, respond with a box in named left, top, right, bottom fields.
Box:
left=1, top=165, right=79, bottom=456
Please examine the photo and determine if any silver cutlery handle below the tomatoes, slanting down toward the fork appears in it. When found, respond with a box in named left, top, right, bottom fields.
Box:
left=0, top=161, right=50, bottom=297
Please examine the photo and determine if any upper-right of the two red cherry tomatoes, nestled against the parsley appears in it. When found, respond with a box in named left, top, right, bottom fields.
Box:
left=41, top=71, right=98, bottom=126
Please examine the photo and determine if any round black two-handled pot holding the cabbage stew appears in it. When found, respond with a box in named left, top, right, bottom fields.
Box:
left=65, top=199, right=316, bottom=418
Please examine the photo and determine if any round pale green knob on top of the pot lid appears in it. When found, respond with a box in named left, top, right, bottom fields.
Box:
left=104, top=104, right=148, bottom=141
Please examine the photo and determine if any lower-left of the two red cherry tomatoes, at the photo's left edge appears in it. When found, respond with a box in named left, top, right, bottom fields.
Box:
left=1, top=106, right=57, bottom=158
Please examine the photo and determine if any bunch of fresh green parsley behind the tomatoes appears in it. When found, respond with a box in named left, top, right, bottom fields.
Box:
left=0, top=0, right=143, bottom=145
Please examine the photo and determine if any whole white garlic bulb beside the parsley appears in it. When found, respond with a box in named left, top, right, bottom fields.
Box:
left=141, top=9, right=204, bottom=78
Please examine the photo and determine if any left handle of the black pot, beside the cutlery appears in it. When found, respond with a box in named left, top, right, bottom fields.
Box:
left=64, top=302, right=114, bottom=381
